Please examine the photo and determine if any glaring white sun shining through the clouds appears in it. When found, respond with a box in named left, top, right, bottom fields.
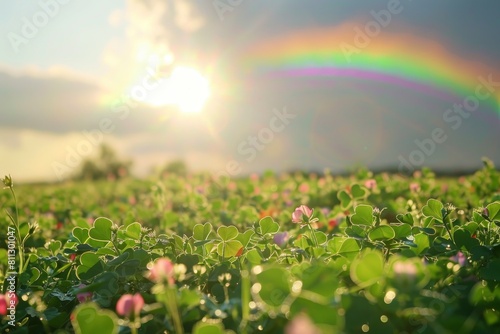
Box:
left=144, top=66, right=210, bottom=113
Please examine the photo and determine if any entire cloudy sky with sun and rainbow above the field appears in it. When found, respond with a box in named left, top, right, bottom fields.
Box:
left=0, top=0, right=500, bottom=181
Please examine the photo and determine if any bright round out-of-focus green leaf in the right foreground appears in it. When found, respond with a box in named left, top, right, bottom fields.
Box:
left=351, top=249, right=384, bottom=287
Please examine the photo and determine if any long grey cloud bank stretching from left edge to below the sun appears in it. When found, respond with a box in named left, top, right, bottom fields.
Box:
left=0, top=64, right=186, bottom=136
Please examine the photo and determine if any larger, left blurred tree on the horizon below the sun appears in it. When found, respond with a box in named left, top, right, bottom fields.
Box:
left=74, top=143, right=132, bottom=180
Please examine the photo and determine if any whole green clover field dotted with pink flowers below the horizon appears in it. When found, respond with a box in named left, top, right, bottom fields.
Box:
left=0, top=161, right=500, bottom=334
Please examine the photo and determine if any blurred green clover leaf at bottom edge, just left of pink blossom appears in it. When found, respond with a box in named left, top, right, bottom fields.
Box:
left=72, top=303, right=118, bottom=334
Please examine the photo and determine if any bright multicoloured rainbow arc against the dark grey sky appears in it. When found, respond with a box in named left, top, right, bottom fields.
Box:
left=243, top=23, right=500, bottom=114
